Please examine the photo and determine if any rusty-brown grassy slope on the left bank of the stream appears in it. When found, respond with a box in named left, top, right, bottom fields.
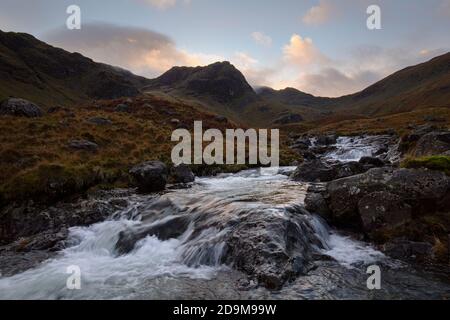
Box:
left=0, top=94, right=299, bottom=205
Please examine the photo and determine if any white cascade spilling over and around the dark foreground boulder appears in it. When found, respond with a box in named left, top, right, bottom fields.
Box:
left=0, top=168, right=400, bottom=299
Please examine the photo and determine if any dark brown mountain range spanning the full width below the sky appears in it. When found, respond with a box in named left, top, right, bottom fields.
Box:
left=0, top=31, right=450, bottom=126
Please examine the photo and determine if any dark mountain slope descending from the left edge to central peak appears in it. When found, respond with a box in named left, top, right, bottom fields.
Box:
left=0, top=30, right=148, bottom=106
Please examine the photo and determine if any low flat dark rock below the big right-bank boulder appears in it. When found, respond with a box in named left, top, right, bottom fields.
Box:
left=383, top=239, right=433, bottom=261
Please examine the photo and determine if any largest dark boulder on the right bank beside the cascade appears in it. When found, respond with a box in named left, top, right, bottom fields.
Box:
left=327, top=168, right=450, bottom=231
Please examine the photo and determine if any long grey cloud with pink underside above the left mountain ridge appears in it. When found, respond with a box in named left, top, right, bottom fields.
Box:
left=45, top=23, right=223, bottom=77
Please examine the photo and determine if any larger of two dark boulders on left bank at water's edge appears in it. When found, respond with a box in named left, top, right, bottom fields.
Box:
left=130, top=161, right=168, bottom=192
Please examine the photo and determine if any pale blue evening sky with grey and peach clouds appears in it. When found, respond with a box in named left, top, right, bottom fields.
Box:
left=0, top=0, right=450, bottom=97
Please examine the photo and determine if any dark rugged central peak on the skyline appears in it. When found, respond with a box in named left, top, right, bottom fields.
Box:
left=145, top=62, right=257, bottom=107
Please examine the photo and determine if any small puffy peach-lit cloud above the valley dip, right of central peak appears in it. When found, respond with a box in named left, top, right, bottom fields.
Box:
left=283, top=34, right=327, bottom=66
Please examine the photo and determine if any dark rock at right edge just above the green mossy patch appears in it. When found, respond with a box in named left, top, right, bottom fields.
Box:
left=412, top=131, right=450, bottom=157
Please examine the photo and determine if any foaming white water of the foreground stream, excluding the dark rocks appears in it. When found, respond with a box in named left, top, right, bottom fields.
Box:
left=0, top=168, right=385, bottom=299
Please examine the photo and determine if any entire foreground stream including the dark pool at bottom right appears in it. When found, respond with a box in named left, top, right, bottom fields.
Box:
left=0, top=137, right=450, bottom=299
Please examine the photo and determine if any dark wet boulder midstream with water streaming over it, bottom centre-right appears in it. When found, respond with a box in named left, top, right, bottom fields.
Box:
left=224, top=208, right=321, bottom=290
